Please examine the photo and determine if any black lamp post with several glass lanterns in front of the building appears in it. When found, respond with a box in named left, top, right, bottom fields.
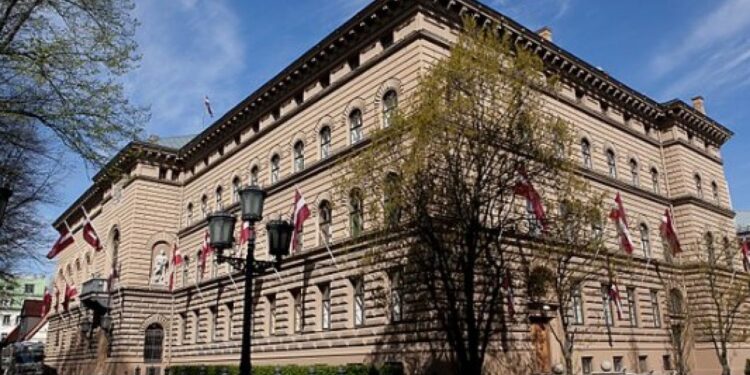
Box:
left=208, top=186, right=293, bottom=375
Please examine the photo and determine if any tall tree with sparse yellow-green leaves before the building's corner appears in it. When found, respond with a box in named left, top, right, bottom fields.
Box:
left=339, top=19, right=592, bottom=375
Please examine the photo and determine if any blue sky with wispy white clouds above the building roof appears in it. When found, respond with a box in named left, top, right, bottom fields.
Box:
left=33, top=0, right=750, bottom=270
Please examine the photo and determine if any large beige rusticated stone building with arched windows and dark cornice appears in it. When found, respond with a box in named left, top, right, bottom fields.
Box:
left=46, top=0, right=750, bottom=375
